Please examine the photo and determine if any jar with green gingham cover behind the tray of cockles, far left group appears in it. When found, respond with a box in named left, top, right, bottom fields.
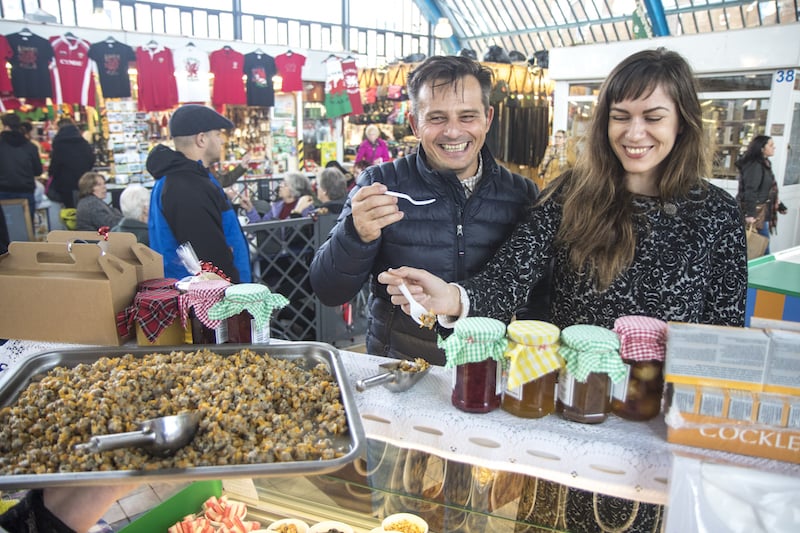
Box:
left=208, top=283, right=289, bottom=344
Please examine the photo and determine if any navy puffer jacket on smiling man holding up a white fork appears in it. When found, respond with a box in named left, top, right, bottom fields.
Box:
left=311, top=145, right=537, bottom=364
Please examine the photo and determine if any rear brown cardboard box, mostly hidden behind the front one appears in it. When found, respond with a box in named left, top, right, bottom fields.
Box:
left=47, top=230, right=164, bottom=281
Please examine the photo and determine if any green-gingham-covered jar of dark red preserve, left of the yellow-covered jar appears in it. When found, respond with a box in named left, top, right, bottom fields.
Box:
left=439, top=317, right=508, bottom=413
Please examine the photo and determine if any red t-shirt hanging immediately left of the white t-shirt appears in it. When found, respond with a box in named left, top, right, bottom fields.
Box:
left=136, top=42, right=178, bottom=111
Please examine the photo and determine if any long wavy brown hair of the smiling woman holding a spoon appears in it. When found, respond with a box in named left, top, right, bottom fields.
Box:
left=545, top=48, right=711, bottom=290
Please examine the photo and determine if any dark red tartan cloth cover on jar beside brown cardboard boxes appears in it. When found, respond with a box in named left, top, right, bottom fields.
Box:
left=117, top=288, right=180, bottom=342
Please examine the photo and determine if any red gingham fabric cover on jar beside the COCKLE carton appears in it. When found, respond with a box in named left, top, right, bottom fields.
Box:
left=614, top=315, right=667, bottom=361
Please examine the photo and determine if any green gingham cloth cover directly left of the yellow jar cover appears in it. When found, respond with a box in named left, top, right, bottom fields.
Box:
left=437, top=316, right=508, bottom=368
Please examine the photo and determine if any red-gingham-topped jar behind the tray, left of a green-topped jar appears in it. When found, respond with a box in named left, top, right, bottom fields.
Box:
left=180, top=279, right=231, bottom=344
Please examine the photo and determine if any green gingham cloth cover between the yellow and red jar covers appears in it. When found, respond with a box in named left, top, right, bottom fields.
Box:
left=558, top=324, right=627, bottom=383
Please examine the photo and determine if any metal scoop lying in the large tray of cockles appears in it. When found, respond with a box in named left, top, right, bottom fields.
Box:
left=75, top=413, right=200, bottom=456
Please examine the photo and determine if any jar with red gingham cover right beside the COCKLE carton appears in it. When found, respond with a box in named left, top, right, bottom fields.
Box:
left=611, top=315, right=667, bottom=420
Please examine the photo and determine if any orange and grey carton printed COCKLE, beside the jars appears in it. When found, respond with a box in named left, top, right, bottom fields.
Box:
left=664, top=323, right=800, bottom=463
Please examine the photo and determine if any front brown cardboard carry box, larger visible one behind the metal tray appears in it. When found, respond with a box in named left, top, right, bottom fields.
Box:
left=0, top=241, right=137, bottom=346
